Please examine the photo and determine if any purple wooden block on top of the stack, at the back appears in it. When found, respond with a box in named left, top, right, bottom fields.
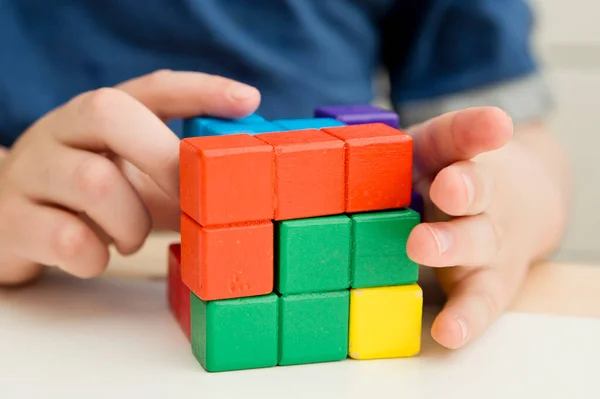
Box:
left=315, top=105, right=400, bottom=129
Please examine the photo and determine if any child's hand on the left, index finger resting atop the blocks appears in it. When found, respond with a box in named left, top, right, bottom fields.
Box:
left=0, top=71, right=260, bottom=284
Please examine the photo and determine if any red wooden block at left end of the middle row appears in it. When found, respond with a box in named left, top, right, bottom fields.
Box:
left=181, top=214, right=274, bottom=301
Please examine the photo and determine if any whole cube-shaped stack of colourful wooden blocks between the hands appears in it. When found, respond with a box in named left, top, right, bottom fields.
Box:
left=168, top=106, right=423, bottom=372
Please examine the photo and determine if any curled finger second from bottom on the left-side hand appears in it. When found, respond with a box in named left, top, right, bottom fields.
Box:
left=17, top=143, right=152, bottom=254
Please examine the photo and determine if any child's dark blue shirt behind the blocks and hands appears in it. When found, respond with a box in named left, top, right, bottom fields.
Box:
left=0, top=0, right=535, bottom=146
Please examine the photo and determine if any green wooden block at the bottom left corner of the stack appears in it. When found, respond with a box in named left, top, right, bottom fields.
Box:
left=191, top=293, right=279, bottom=372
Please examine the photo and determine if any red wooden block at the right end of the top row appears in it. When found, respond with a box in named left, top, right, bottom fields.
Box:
left=323, top=123, right=413, bottom=213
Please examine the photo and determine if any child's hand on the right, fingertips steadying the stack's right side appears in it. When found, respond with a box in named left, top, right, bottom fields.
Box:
left=408, top=108, right=567, bottom=348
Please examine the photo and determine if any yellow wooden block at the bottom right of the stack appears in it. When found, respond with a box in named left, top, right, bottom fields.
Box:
left=348, top=284, right=423, bottom=360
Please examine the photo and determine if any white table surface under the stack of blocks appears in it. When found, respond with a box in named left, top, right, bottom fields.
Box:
left=0, top=275, right=600, bottom=399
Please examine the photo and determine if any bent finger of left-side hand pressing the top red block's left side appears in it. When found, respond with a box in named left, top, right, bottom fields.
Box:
left=51, top=89, right=179, bottom=199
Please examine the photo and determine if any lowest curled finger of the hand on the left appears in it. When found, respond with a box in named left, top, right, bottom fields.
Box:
left=0, top=198, right=109, bottom=278
